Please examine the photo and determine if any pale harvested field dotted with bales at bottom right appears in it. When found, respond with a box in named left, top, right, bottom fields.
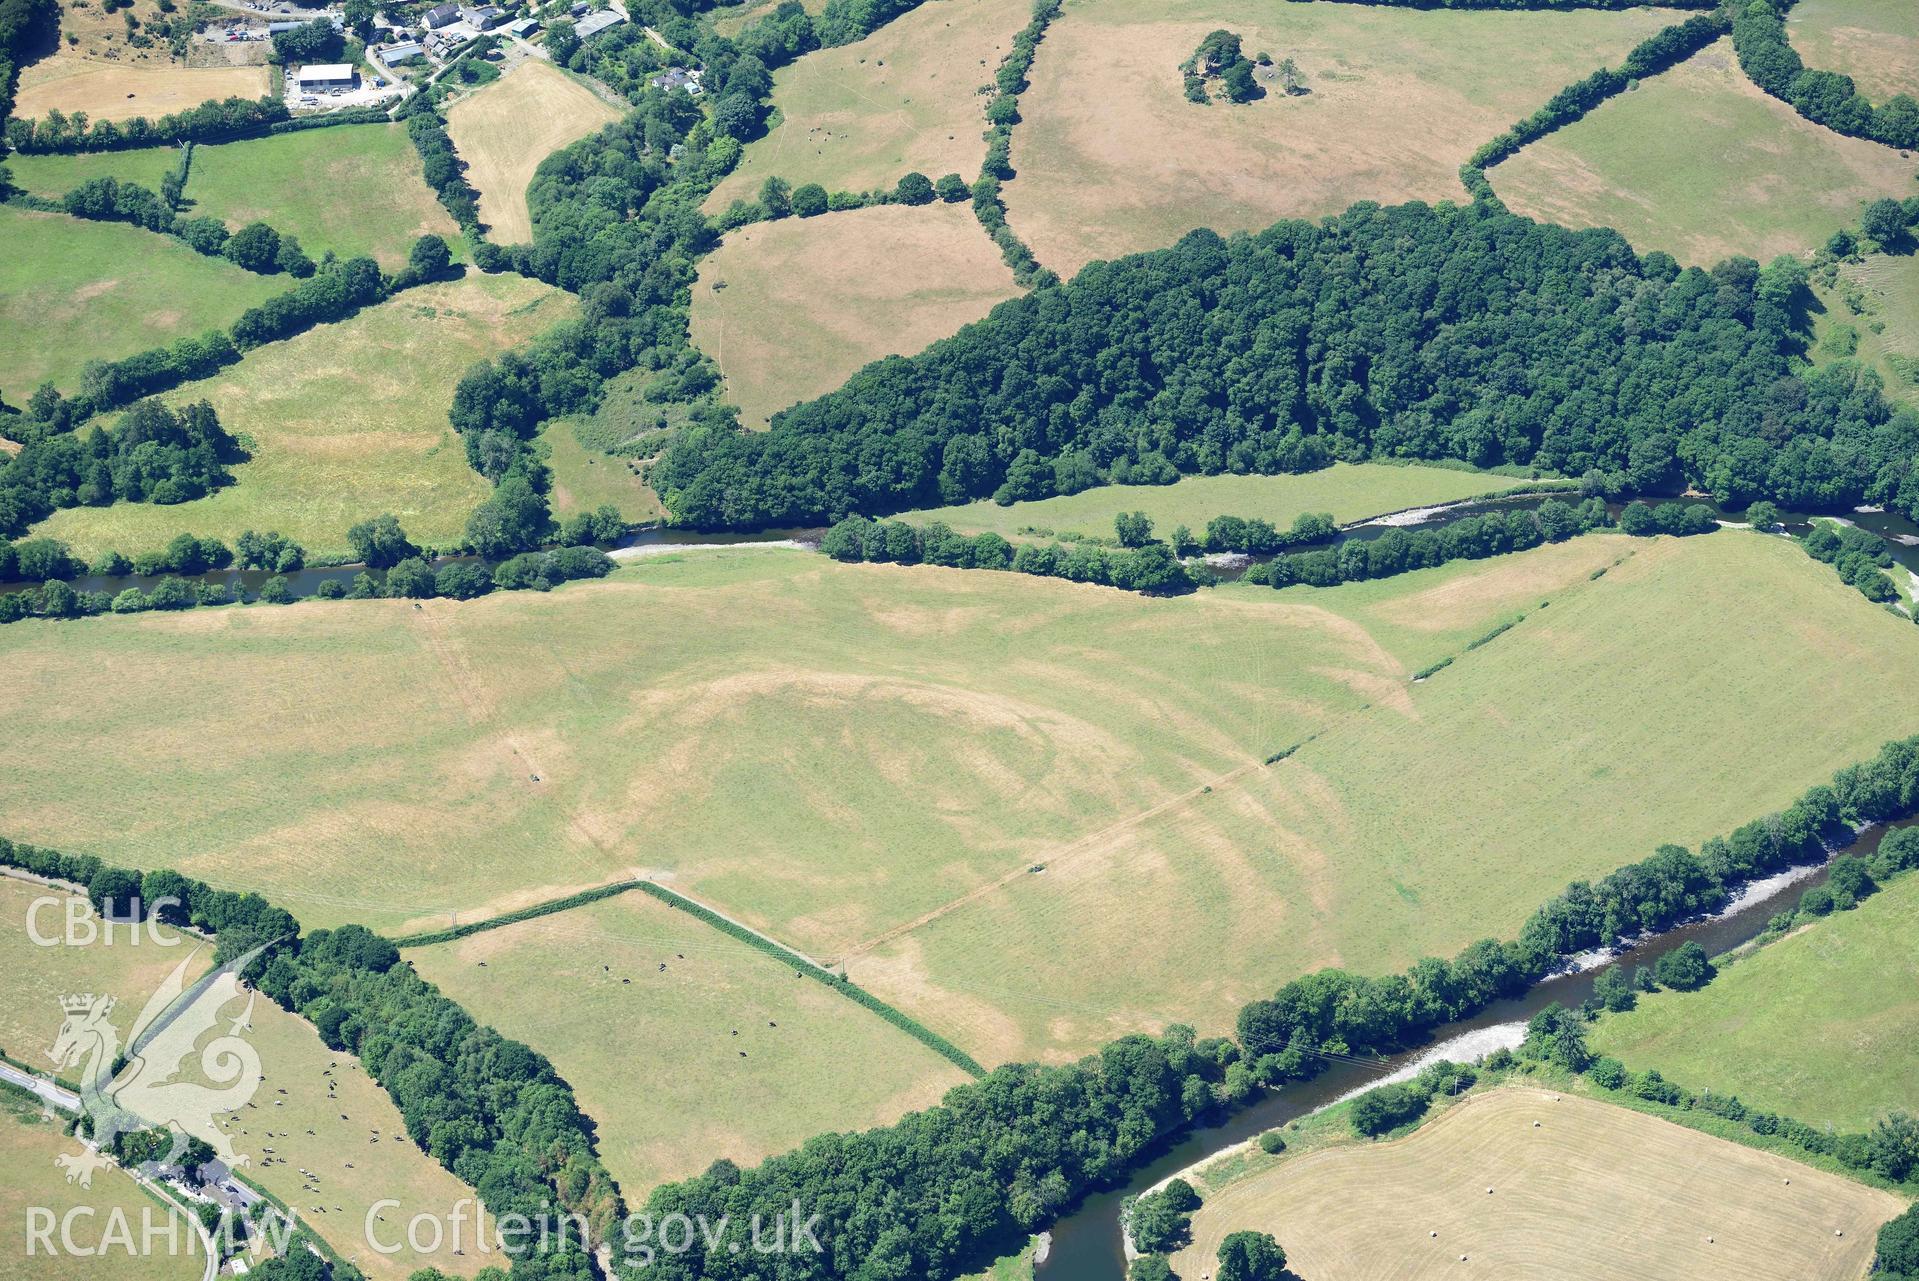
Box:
left=1173, top=1085, right=1906, bottom=1281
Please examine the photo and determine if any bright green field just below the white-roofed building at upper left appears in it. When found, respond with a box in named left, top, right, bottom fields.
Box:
left=184, top=125, right=464, bottom=270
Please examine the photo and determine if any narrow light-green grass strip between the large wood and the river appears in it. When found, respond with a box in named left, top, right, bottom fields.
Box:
left=900, top=462, right=1558, bottom=541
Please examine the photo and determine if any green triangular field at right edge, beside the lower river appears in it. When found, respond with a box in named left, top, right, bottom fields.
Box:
left=1591, top=876, right=1919, bottom=1131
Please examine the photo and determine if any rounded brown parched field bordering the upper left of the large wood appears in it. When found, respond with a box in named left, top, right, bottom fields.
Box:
left=693, top=203, right=1019, bottom=428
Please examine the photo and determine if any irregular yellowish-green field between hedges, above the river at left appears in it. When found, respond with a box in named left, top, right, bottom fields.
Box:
left=35, top=274, right=572, bottom=558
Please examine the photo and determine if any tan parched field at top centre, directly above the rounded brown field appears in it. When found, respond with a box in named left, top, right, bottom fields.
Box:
left=706, top=0, right=1032, bottom=213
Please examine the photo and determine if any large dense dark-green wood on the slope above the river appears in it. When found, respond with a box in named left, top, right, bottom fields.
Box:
left=652, top=203, right=1919, bottom=527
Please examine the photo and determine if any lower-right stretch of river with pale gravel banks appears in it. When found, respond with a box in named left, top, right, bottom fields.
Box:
left=1034, top=819, right=1919, bottom=1281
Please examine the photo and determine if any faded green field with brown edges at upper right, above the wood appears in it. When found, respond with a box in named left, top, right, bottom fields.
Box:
left=1487, top=40, right=1919, bottom=267
